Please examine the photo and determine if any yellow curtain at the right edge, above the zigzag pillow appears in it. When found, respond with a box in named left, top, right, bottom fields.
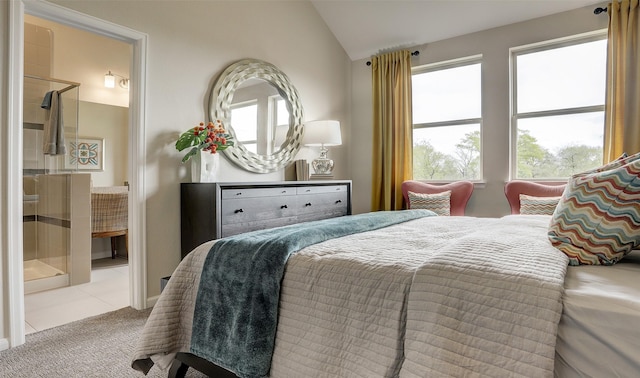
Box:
left=604, top=0, right=640, bottom=163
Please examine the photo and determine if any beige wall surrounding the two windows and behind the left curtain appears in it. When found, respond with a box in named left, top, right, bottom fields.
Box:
left=349, top=5, right=608, bottom=217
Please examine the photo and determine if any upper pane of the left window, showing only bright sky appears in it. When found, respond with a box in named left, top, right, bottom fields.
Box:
left=411, top=63, right=481, bottom=124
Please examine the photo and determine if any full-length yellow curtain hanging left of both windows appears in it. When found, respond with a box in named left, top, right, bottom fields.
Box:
left=371, top=50, right=413, bottom=211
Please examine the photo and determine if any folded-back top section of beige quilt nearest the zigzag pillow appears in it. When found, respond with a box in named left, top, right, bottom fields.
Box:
left=400, top=215, right=568, bottom=378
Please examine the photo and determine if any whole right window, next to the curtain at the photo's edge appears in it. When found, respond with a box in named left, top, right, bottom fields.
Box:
left=511, top=34, right=607, bottom=179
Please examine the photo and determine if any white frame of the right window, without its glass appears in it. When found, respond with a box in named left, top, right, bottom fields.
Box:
left=509, top=29, right=607, bottom=183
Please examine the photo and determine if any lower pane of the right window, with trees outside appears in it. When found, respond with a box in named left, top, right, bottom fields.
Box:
left=516, top=112, right=604, bottom=179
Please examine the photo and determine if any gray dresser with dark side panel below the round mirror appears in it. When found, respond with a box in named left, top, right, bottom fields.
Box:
left=180, top=180, right=351, bottom=258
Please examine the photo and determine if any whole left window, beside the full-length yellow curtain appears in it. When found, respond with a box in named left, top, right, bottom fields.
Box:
left=411, top=57, right=482, bottom=181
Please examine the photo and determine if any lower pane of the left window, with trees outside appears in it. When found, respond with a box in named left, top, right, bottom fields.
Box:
left=413, top=124, right=480, bottom=180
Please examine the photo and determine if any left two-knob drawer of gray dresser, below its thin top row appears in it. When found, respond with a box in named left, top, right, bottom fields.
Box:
left=220, top=196, right=296, bottom=224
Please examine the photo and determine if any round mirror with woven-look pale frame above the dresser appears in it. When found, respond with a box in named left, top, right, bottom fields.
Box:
left=209, top=59, right=303, bottom=173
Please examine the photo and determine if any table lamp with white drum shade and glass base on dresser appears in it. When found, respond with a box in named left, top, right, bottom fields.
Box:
left=302, top=120, right=342, bottom=176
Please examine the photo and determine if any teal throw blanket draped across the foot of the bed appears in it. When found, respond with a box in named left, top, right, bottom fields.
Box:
left=191, top=210, right=435, bottom=378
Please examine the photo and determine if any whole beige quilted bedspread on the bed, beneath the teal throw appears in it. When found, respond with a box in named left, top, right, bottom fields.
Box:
left=133, top=216, right=567, bottom=377
